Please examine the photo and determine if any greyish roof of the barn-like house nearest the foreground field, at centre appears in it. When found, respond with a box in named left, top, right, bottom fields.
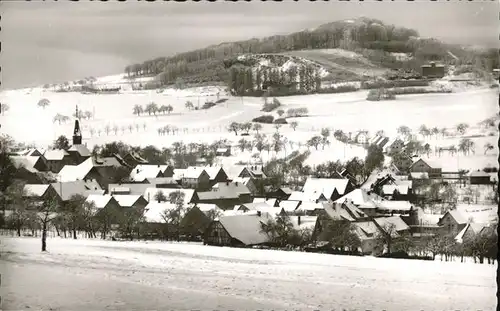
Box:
left=219, top=213, right=272, bottom=245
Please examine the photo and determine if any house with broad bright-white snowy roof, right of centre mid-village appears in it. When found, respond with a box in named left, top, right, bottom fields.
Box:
left=300, top=177, right=354, bottom=201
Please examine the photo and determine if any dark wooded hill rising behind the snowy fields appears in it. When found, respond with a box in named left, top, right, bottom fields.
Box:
left=125, top=18, right=499, bottom=93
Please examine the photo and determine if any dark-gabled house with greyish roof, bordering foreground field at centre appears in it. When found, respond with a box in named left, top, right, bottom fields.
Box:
left=203, top=212, right=273, bottom=246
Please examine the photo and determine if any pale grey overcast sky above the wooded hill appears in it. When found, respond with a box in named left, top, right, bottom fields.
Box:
left=0, top=0, right=499, bottom=89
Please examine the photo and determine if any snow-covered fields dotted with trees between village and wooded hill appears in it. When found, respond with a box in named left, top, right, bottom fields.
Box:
left=0, top=75, right=498, bottom=170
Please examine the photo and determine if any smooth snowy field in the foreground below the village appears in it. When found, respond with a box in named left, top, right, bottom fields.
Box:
left=0, top=238, right=496, bottom=310
